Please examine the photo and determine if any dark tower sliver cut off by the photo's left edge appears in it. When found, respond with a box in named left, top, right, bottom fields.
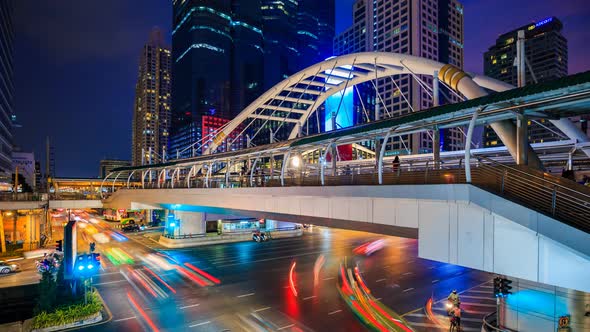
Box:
left=0, top=0, right=14, bottom=175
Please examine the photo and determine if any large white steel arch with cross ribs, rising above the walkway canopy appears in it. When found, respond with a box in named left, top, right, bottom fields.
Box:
left=203, top=52, right=540, bottom=166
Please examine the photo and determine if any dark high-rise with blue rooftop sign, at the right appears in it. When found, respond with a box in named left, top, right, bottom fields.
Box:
left=483, top=17, right=568, bottom=147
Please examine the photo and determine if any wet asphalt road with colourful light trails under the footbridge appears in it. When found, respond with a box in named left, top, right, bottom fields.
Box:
left=77, top=222, right=495, bottom=331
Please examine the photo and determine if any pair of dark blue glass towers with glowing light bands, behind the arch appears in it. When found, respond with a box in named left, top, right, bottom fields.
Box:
left=169, top=0, right=334, bottom=158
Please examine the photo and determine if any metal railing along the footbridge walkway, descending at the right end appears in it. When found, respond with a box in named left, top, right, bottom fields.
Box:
left=127, top=157, right=590, bottom=232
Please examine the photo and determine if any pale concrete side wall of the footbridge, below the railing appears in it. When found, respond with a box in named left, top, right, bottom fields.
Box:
left=104, top=185, right=590, bottom=292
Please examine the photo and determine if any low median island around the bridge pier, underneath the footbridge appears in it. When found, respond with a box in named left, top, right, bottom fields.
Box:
left=158, top=227, right=303, bottom=249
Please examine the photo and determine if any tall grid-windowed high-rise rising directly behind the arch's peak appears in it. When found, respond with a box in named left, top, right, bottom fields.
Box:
left=334, top=0, right=464, bottom=154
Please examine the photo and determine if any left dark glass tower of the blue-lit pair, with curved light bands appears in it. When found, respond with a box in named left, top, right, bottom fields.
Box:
left=170, top=0, right=264, bottom=158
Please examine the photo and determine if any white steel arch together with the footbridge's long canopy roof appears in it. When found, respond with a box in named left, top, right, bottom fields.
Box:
left=103, top=53, right=590, bottom=195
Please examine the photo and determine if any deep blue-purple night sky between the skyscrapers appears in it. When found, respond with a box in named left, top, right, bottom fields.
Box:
left=15, top=0, right=590, bottom=177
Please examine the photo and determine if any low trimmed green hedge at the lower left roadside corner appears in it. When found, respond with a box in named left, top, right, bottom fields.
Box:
left=33, top=292, right=102, bottom=329
